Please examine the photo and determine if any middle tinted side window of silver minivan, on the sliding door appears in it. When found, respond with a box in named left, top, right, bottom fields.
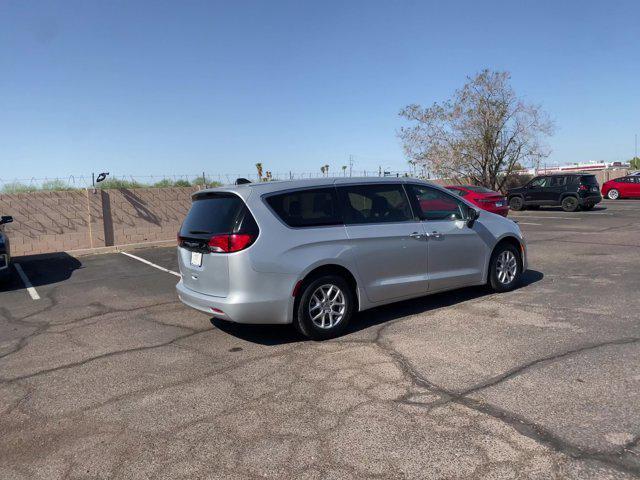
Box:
left=338, top=184, right=413, bottom=225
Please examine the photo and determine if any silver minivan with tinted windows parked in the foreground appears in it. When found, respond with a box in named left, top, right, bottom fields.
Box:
left=176, top=178, right=527, bottom=339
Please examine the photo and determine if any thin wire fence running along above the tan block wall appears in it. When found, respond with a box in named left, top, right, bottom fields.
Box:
left=0, top=169, right=422, bottom=193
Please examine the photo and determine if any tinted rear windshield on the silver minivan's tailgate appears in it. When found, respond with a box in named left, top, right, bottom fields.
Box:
left=180, top=192, right=257, bottom=238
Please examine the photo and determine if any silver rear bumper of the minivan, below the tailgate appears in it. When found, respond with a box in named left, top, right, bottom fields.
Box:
left=176, top=280, right=293, bottom=324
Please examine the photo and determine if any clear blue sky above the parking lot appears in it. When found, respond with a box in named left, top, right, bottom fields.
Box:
left=0, top=0, right=640, bottom=179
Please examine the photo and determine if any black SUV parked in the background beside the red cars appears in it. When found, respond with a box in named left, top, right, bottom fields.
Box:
left=507, top=173, right=602, bottom=212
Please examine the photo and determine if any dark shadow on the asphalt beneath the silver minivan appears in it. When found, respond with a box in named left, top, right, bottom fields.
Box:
left=210, top=270, right=544, bottom=346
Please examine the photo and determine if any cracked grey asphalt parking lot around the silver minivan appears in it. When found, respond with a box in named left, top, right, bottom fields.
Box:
left=0, top=200, right=640, bottom=479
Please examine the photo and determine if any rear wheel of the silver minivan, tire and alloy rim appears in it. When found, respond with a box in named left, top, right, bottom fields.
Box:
left=293, top=275, right=355, bottom=340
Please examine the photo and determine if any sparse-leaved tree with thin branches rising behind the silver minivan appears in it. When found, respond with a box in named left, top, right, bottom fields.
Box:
left=398, top=70, right=554, bottom=190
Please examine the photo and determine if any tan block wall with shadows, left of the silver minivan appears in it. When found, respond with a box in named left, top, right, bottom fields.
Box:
left=0, top=187, right=196, bottom=256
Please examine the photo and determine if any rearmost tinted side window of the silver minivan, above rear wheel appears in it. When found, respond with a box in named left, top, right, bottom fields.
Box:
left=265, top=187, right=342, bottom=227
